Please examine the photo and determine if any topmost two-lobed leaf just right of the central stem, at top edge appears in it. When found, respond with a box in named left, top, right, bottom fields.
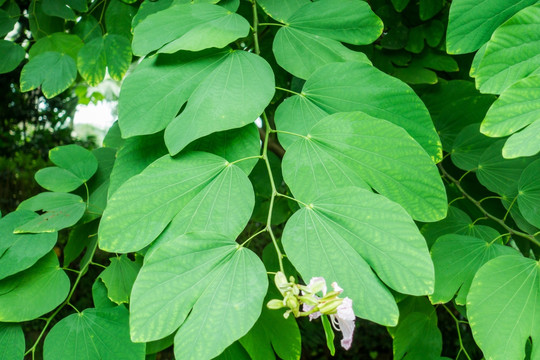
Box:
left=273, top=0, right=383, bottom=79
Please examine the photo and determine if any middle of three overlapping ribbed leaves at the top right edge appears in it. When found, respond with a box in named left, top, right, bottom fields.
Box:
left=475, top=1, right=540, bottom=94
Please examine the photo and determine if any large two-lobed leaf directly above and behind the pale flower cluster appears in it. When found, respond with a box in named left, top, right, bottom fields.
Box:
left=282, top=187, right=434, bottom=326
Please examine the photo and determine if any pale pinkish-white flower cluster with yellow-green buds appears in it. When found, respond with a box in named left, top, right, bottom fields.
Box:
left=267, top=271, right=356, bottom=350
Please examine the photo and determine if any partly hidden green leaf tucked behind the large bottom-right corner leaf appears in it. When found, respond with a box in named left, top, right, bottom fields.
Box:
left=429, top=234, right=519, bottom=305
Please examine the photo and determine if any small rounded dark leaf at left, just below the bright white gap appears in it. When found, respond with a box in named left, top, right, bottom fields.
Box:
left=49, top=144, right=98, bottom=182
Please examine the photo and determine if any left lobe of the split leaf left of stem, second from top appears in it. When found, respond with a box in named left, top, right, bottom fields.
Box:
left=118, top=50, right=226, bottom=138
